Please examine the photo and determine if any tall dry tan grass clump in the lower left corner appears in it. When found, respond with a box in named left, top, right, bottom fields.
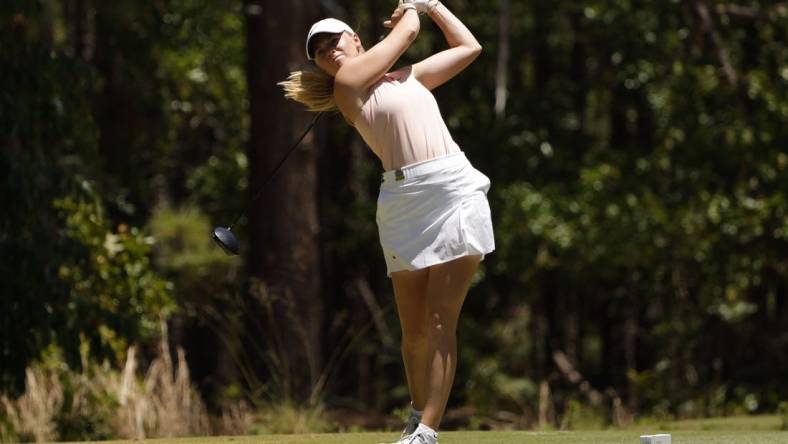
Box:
left=0, top=325, right=253, bottom=442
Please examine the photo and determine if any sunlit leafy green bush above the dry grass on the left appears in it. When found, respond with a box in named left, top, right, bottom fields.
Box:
left=54, top=189, right=174, bottom=362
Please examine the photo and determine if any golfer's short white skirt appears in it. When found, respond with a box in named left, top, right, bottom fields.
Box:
left=376, top=152, right=495, bottom=276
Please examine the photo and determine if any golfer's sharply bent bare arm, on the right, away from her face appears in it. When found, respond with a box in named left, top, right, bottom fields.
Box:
left=413, top=3, right=482, bottom=89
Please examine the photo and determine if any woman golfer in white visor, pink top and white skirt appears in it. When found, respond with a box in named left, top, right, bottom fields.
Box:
left=281, top=0, right=495, bottom=444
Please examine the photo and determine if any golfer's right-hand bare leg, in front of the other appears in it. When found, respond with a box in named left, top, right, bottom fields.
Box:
left=421, top=256, right=481, bottom=430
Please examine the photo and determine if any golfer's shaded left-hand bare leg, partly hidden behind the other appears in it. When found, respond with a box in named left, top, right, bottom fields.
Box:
left=391, top=269, right=429, bottom=410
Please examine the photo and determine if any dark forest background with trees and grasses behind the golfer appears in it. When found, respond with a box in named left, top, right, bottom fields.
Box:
left=0, top=0, right=788, bottom=440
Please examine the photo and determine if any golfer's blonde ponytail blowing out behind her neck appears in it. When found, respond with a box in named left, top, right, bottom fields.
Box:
left=277, top=68, right=338, bottom=112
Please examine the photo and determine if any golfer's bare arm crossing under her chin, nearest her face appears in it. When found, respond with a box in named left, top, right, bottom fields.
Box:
left=334, top=9, right=420, bottom=122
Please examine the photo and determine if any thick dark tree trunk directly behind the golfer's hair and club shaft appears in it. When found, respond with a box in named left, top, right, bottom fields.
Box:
left=244, top=0, right=323, bottom=402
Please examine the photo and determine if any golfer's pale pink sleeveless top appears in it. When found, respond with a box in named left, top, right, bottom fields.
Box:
left=355, top=67, right=460, bottom=171
